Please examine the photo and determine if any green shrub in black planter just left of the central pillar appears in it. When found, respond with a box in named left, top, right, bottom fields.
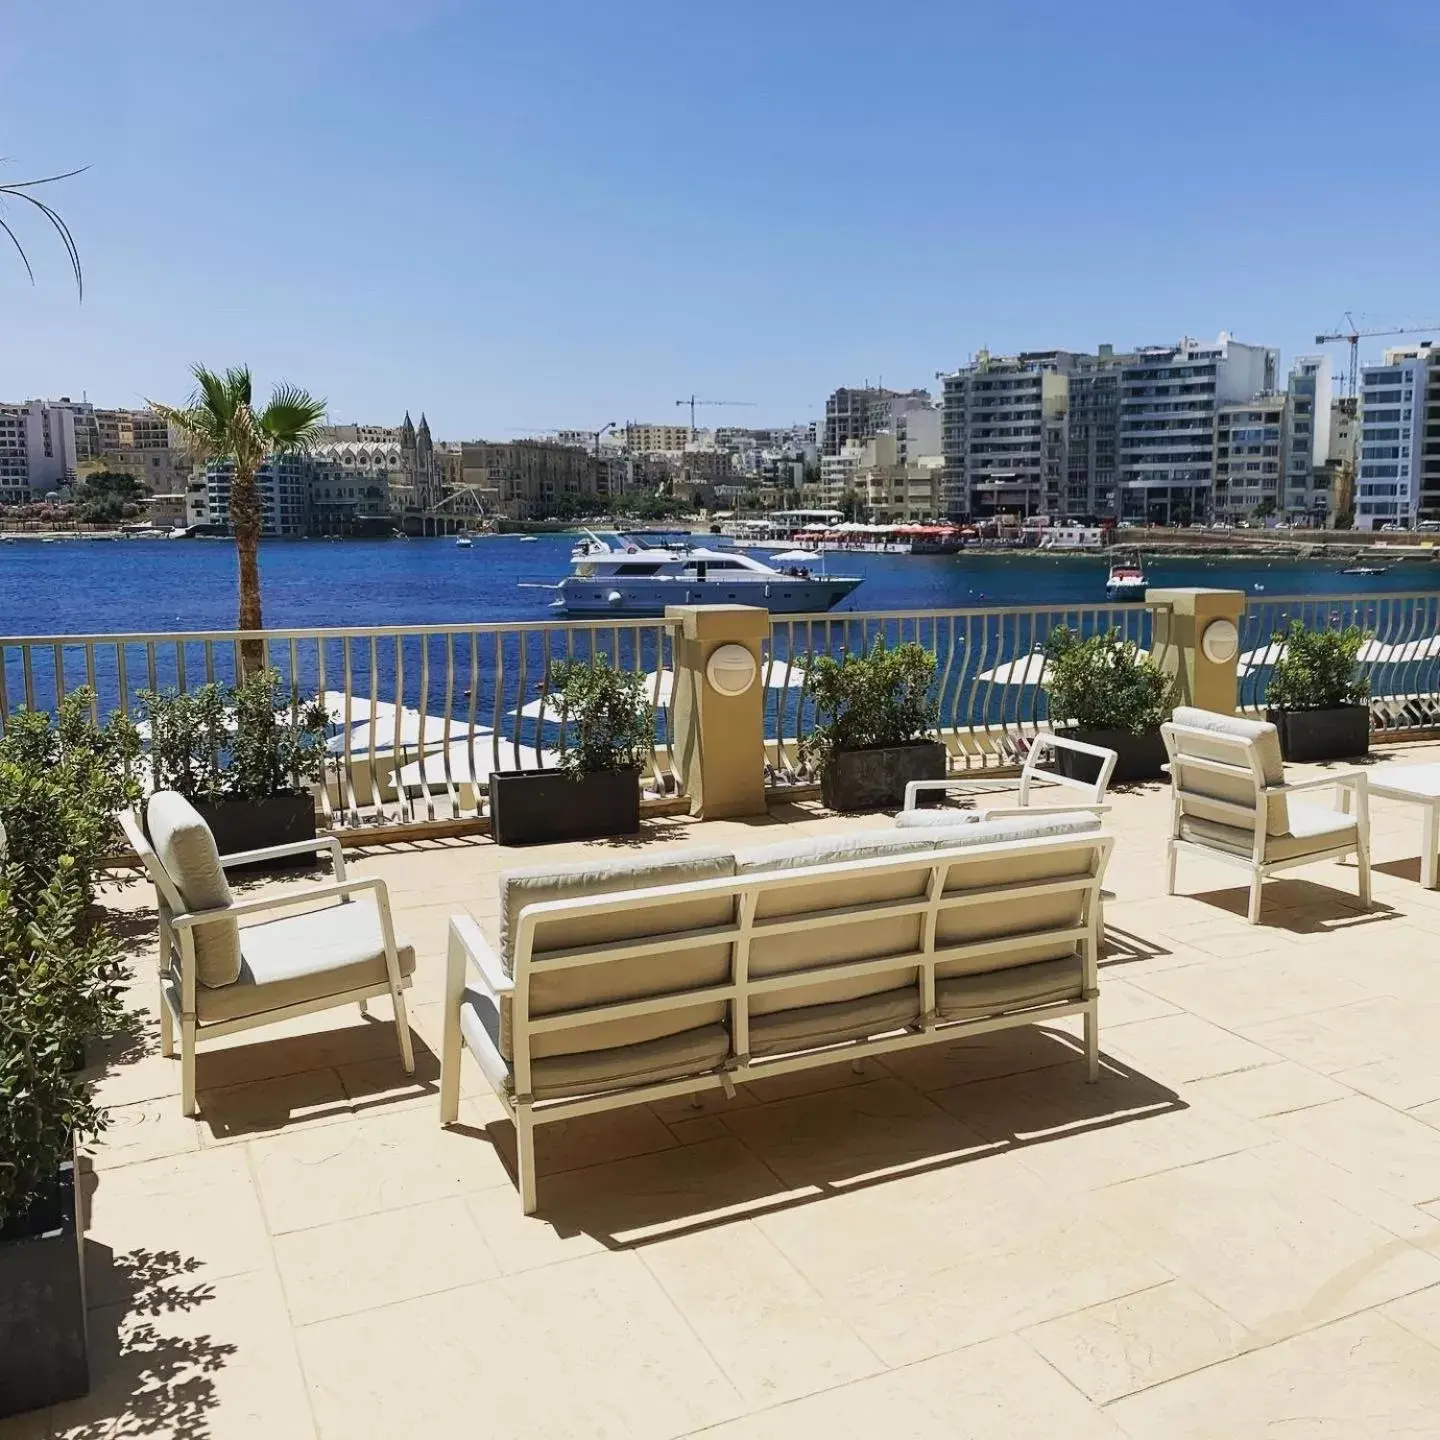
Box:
left=490, top=657, right=655, bottom=845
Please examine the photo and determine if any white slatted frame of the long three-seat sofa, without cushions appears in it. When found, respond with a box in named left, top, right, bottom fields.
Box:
left=441, top=831, right=1113, bottom=1215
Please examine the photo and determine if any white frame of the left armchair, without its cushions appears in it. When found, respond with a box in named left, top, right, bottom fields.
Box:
left=120, top=811, right=415, bottom=1116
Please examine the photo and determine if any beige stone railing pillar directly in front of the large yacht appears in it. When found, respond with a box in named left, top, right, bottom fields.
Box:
left=665, top=605, right=770, bottom=819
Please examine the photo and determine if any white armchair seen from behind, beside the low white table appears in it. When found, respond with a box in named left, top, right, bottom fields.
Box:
left=1161, top=706, right=1369, bottom=924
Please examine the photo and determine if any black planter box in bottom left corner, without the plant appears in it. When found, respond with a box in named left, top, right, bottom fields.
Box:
left=0, top=1159, right=89, bottom=1416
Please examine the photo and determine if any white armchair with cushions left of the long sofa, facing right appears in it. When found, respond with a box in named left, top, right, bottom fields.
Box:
left=121, top=791, right=415, bottom=1115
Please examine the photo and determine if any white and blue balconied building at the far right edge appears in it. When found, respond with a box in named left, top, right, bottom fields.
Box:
left=1355, top=347, right=1422, bottom=530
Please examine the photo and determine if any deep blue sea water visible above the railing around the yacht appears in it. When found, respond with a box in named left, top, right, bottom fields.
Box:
left=0, top=536, right=1440, bottom=636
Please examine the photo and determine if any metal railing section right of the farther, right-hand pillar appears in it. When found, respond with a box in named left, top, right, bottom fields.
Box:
left=1236, top=590, right=1440, bottom=733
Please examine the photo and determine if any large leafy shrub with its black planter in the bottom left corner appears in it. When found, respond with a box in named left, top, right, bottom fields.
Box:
left=0, top=827, right=118, bottom=1416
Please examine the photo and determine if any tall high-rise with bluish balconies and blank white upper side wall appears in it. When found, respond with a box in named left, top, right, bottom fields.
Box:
left=1117, top=333, right=1279, bottom=524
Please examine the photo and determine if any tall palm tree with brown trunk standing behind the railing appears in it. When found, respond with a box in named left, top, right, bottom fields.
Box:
left=155, top=364, right=325, bottom=674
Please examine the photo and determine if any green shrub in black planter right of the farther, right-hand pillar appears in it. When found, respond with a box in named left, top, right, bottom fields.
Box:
left=1266, top=621, right=1369, bottom=762
